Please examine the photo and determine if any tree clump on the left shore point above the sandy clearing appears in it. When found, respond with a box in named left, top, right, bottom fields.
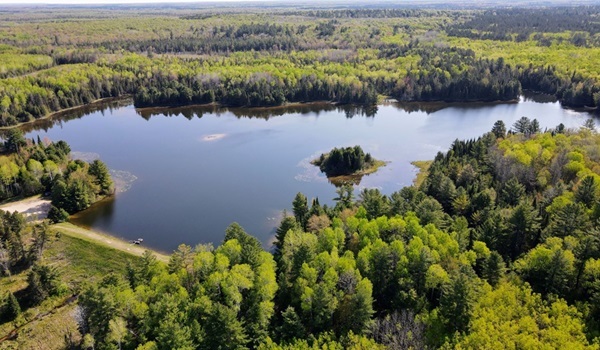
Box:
left=0, top=129, right=114, bottom=221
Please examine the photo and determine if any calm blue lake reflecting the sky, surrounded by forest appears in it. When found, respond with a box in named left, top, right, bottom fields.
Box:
left=25, top=97, right=590, bottom=252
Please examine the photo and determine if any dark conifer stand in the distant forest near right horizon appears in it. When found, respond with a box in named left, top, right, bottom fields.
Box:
left=446, top=6, right=600, bottom=46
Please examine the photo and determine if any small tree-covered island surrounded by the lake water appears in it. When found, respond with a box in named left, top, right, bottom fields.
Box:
left=311, top=146, right=386, bottom=185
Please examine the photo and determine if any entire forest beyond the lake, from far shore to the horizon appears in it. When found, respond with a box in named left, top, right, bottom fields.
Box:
left=0, top=7, right=600, bottom=126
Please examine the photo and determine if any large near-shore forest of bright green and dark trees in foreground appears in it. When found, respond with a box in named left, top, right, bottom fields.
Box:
left=65, top=118, right=600, bottom=349
